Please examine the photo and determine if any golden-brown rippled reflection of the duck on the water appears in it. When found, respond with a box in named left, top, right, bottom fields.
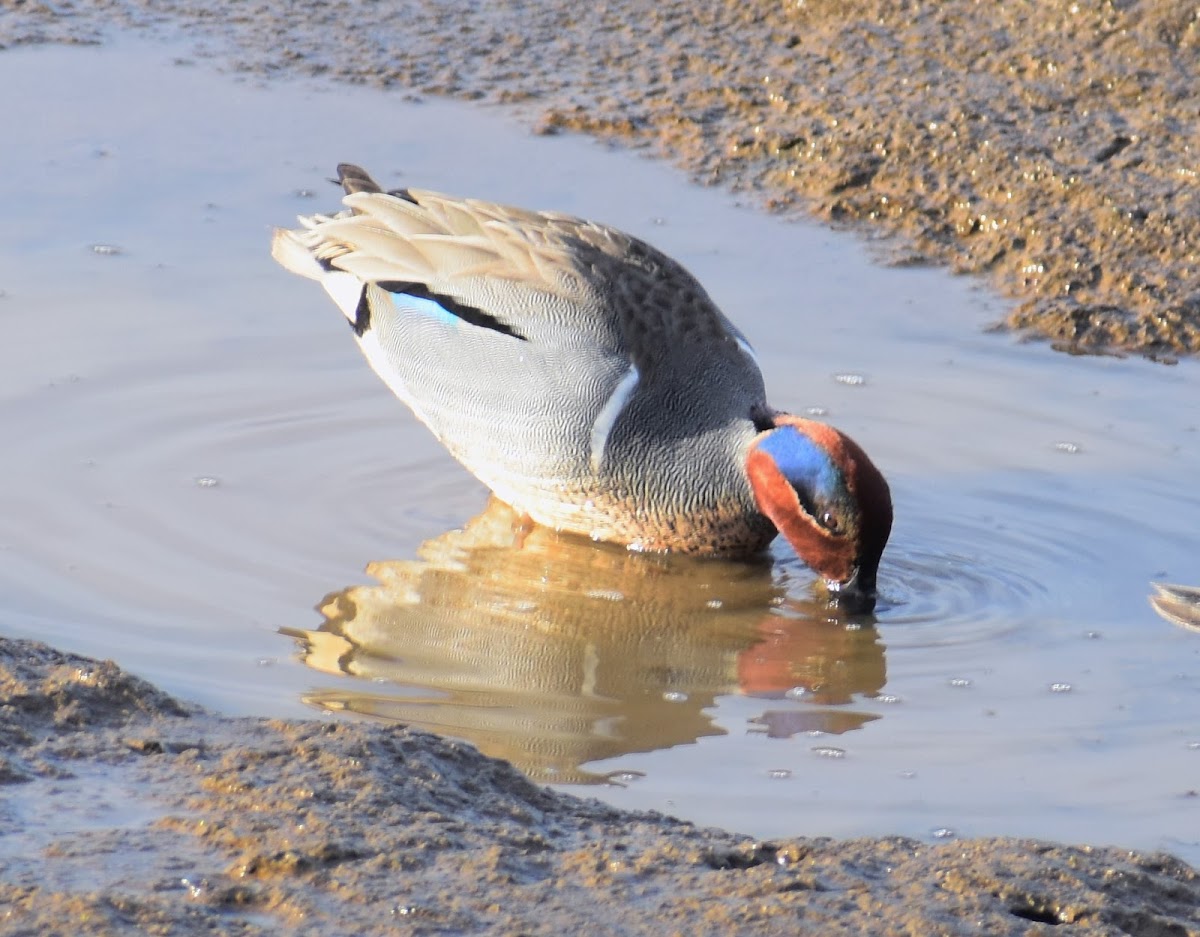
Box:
left=283, top=500, right=884, bottom=782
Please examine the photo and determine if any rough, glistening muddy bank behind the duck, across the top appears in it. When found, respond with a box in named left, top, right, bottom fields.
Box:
left=0, top=0, right=1200, bottom=354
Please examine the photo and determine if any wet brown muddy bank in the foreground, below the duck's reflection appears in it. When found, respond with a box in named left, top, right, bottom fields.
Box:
left=0, top=639, right=1200, bottom=937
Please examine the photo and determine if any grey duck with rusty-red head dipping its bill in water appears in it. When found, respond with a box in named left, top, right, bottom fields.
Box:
left=271, top=163, right=893, bottom=613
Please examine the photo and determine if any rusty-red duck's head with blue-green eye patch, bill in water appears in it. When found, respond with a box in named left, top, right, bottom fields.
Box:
left=746, top=414, right=892, bottom=613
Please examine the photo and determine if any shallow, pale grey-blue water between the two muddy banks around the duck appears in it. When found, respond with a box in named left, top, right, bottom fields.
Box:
left=0, top=43, right=1200, bottom=863
